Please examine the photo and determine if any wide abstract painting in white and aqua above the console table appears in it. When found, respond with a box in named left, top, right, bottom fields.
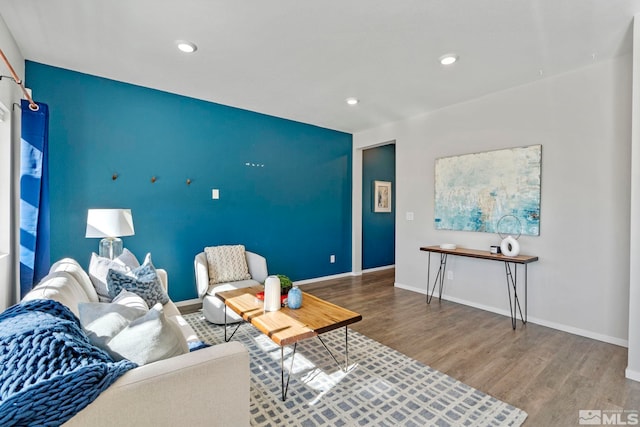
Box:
left=434, top=145, right=542, bottom=236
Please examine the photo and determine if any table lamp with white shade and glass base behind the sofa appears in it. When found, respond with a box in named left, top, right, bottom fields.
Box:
left=85, top=209, right=135, bottom=259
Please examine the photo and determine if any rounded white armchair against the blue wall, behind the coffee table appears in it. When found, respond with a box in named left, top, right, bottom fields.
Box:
left=193, top=251, right=269, bottom=325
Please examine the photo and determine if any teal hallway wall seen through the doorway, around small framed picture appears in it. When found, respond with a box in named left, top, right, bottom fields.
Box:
left=362, top=144, right=396, bottom=269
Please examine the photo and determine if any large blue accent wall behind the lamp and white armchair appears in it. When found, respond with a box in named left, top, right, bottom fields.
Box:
left=25, top=61, right=352, bottom=301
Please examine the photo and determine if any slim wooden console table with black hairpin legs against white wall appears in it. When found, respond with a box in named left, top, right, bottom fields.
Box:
left=420, top=246, right=538, bottom=329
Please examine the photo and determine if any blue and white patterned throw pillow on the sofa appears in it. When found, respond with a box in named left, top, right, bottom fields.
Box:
left=107, top=254, right=169, bottom=307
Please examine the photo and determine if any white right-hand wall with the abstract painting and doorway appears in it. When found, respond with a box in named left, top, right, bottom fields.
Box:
left=354, top=55, right=631, bottom=345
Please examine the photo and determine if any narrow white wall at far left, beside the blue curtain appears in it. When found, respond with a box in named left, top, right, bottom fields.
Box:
left=0, top=18, right=24, bottom=311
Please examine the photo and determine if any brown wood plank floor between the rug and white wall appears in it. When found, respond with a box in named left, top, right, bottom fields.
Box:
left=181, top=269, right=640, bottom=427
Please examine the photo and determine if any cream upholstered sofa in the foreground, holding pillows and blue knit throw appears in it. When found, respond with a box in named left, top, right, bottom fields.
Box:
left=16, top=258, right=250, bottom=427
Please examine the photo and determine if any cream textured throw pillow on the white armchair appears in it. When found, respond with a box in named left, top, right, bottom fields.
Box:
left=204, top=245, right=251, bottom=285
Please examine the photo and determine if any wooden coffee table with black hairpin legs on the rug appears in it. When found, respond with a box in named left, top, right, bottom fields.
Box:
left=216, top=286, right=362, bottom=401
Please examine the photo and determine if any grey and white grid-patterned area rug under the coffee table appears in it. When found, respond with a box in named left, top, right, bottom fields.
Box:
left=184, top=313, right=527, bottom=427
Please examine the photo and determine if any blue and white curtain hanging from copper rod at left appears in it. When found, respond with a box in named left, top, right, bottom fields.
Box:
left=20, top=100, right=50, bottom=298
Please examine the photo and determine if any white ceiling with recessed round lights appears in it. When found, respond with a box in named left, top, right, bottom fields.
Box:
left=0, top=0, right=640, bottom=133
